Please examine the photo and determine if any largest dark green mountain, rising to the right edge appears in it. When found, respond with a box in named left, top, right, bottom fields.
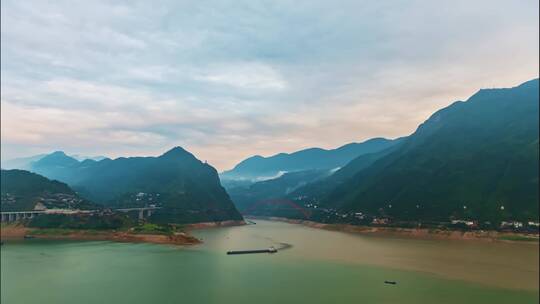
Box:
left=310, top=79, right=539, bottom=221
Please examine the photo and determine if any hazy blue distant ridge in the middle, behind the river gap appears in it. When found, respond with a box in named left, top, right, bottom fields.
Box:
left=220, top=138, right=395, bottom=181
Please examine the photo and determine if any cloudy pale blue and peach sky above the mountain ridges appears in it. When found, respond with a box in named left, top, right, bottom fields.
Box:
left=1, top=0, right=539, bottom=171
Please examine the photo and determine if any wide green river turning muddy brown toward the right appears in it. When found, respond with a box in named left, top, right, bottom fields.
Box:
left=1, top=221, right=539, bottom=304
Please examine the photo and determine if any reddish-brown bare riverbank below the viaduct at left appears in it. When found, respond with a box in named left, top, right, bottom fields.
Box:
left=0, top=225, right=201, bottom=245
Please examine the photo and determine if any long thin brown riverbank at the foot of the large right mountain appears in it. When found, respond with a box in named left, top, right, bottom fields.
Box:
left=249, top=216, right=539, bottom=245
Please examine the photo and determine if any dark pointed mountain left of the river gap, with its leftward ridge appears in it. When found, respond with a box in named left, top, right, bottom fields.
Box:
left=28, top=147, right=242, bottom=223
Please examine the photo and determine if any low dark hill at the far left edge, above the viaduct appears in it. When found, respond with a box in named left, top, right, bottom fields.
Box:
left=0, top=169, right=95, bottom=211
